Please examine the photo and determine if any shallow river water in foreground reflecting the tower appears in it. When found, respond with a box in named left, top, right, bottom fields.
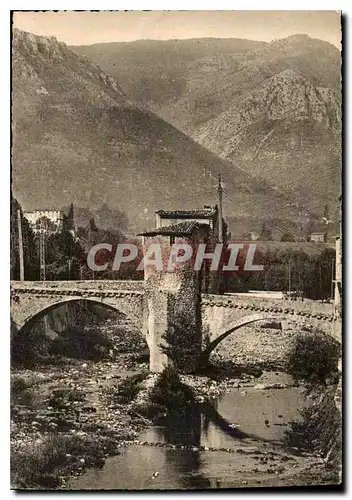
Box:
left=68, top=380, right=316, bottom=490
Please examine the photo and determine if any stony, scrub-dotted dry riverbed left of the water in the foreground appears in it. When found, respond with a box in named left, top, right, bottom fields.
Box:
left=11, top=361, right=148, bottom=488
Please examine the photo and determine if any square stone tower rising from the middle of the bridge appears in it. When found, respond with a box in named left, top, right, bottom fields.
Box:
left=139, top=221, right=209, bottom=373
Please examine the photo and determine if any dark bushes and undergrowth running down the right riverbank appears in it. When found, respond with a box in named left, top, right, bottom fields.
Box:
left=285, top=330, right=342, bottom=484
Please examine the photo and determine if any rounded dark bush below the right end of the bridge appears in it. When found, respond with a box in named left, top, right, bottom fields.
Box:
left=287, top=330, right=341, bottom=385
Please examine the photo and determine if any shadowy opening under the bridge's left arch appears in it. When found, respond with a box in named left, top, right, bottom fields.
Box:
left=11, top=298, right=149, bottom=366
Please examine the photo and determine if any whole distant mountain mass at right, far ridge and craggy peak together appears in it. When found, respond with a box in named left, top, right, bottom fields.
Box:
left=76, top=35, right=341, bottom=219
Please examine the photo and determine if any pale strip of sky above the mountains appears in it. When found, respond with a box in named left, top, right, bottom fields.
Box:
left=13, top=10, right=341, bottom=48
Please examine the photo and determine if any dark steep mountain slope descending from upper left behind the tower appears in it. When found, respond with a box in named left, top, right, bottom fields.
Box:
left=12, top=30, right=297, bottom=233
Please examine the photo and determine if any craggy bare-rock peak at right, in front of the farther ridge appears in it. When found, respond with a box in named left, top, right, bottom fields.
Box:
left=195, top=70, right=341, bottom=217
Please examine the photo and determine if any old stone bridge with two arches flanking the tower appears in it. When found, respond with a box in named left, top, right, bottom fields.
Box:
left=11, top=279, right=336, bottom=371
